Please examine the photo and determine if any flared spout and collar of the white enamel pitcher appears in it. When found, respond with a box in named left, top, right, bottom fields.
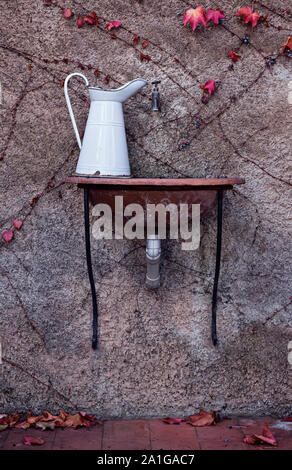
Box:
left=88, top=78, right=147, bottom=103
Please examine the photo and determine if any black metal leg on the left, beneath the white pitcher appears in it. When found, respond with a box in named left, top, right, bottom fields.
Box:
left=84, top=188, right=98, bottom=349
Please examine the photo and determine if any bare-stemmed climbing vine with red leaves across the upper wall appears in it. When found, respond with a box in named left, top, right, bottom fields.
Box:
left=0, top=0, right=292, bottom=352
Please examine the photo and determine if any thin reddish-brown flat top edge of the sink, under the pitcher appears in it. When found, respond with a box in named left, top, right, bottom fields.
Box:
left=66, top=175, right=245, bottom=187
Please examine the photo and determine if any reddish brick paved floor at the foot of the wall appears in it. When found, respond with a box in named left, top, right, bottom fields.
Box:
left=0, top=418, right=292, bottom=450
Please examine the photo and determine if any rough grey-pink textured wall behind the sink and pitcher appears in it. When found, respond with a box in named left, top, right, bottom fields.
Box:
left=0, top=0, right=292, bottom=417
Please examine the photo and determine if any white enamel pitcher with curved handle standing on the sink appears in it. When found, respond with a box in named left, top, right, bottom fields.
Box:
left=64, top=72, right=147, bottom=177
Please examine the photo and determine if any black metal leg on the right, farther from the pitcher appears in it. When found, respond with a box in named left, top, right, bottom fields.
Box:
left=212, top=190, right=223, bottom=346
